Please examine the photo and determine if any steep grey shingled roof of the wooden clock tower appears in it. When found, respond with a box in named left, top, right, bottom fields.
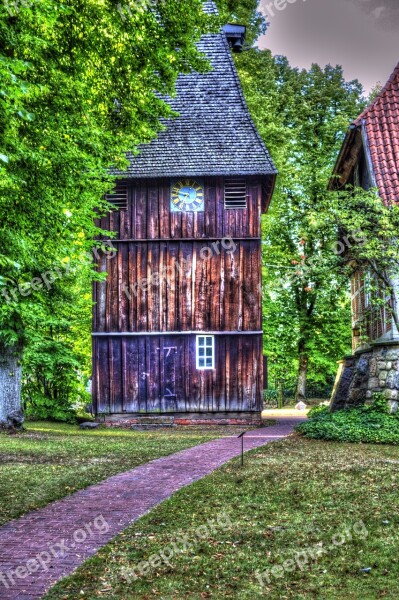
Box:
left=120, top=2, right=276, bottom=178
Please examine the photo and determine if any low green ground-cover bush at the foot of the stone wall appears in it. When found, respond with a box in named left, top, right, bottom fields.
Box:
left=296, top=394, right=399, bottom=444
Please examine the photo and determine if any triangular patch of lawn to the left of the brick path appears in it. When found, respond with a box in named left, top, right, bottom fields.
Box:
left=0, top=422, right=247, bottom=525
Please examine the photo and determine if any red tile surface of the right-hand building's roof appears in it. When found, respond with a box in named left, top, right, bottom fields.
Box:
left=354, top=63, right=399, bottom=204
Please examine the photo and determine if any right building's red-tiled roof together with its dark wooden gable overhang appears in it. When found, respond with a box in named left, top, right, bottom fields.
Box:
left=334, top=63, right=399, bottom=204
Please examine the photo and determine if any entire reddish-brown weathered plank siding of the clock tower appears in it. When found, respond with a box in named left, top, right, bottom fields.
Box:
left=93, top=178, right=263, bottom=414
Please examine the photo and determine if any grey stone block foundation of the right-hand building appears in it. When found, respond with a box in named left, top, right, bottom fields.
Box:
left=331, top=341, right=399, bottom=410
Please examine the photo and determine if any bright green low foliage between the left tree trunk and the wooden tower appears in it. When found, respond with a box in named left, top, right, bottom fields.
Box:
left=22, top=273, right=91, bottom=421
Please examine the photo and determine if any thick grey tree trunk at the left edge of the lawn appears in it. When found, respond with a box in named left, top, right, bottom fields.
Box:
left=0, top=344, right=24, bottom=429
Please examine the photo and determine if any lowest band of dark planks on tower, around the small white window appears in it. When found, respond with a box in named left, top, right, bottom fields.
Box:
left=94, top=335, right=262, bottom=413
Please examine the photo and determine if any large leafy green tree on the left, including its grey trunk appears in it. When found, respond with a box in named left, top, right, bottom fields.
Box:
left=0, top=0, right=212, bottom=425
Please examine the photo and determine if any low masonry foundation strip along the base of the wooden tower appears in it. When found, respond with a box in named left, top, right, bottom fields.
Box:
left=104, top=412, right=263, bottom=429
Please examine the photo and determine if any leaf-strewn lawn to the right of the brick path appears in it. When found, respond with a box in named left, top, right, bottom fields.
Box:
left=46, top=436, right=399, bottom=600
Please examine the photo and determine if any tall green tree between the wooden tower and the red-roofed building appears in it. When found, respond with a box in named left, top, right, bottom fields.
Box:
left=237, top=49, right=363, bottom=399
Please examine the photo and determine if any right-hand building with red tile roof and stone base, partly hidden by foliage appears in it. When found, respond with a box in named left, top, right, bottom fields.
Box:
left=331, top=64, right=399, bottom=409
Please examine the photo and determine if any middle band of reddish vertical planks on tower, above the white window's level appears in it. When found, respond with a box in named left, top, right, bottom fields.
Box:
left=94, top=241, right=262, bottom=333
